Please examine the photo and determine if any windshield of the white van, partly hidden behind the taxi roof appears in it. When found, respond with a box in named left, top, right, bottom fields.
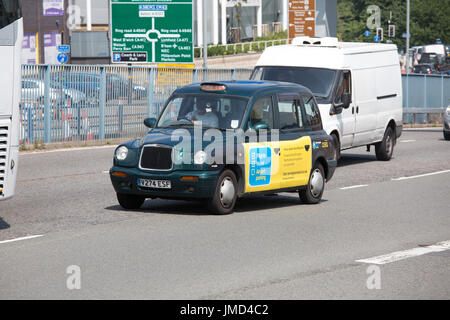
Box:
left=251, top=67, right=336, bottom=98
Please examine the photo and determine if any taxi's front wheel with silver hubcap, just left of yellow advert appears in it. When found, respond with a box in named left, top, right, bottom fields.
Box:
left=209, top=170, right=237, bottom=215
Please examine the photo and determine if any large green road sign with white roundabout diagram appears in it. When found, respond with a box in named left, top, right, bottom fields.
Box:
left=111, top=0, right=194, bottom=63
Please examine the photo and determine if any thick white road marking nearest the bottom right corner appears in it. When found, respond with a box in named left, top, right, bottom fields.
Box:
left=356, top=241, right=450, bottom=264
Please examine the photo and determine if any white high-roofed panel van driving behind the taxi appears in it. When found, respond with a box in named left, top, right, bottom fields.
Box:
left=252, top=37, right=403, bottom=161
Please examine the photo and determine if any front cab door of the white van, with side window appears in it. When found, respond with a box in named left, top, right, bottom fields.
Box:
left=331, top=70, right=355, bottom=149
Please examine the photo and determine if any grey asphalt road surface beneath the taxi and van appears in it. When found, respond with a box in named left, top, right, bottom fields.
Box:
left=0, top=129, right=450, bottom=299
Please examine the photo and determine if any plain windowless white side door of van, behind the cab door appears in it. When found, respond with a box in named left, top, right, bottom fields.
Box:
left=351, top=69, right=379, bottom=147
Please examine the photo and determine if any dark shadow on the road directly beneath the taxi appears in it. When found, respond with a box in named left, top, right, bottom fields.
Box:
left=105, top=194, right=327, bottom=216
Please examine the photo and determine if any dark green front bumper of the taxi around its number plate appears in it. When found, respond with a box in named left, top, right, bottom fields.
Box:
left=109, top=166, right=220, bottom=199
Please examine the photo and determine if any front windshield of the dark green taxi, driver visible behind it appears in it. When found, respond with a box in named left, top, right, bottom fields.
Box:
left=157, top=94, right=248, bottom=130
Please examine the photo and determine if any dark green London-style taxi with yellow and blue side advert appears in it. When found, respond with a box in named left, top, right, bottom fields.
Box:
left=110, top=81, right=337, bottom=214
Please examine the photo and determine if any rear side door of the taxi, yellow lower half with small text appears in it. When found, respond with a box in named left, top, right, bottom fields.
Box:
left=277, top=93, right=313, bottom=189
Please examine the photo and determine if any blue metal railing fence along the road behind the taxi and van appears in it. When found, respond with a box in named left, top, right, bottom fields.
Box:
left=20, top=65, right=450, bottom=144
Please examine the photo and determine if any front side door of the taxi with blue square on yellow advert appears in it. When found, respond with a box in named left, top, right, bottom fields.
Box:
left=244, top=95, right=280, bottom=193
